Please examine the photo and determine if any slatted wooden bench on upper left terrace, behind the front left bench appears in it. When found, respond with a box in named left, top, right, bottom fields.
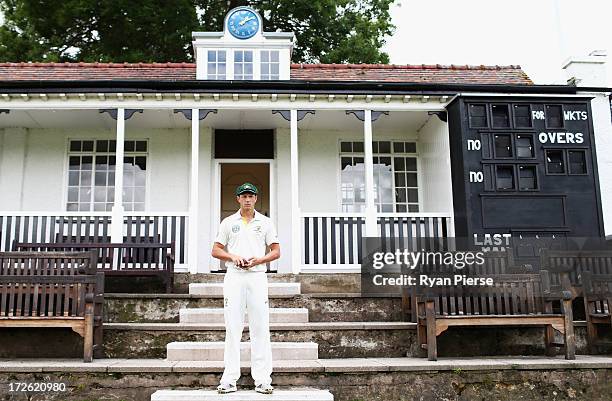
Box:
left=13, top=241, right=175, bottom=293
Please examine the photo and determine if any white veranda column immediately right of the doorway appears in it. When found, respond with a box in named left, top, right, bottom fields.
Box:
left=290, top=110, right=303, bottom=274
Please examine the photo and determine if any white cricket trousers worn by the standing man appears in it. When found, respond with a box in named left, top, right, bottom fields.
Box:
left=221, top=268, right=272, bottom=386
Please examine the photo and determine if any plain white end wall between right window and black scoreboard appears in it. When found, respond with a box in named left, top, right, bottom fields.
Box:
left=418, top=116, right=453, bottom=213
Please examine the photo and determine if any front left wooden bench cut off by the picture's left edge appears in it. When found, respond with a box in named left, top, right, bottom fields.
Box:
left=0, top=252, right=104, bottom=362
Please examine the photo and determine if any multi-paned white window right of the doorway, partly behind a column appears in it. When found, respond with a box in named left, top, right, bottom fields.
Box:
left=340, top=141, right=419, bottom=212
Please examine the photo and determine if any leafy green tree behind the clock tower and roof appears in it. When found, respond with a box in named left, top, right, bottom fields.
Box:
left=0, top=0, right=395, bottom=63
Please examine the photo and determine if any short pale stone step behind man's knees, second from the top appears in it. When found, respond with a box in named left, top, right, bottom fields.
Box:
left=179, top=308, right=308, bottom=323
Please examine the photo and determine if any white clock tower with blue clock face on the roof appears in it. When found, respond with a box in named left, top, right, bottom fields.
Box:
left=193, top=7, right=295, bottom=81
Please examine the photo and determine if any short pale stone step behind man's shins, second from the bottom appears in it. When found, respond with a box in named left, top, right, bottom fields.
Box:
left=166, top=341, right=319, bottom=361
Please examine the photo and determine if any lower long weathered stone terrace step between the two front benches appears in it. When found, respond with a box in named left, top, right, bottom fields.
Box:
left=103, top=322, right=416, bottom=358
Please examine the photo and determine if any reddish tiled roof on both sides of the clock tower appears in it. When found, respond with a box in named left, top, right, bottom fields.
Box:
left=0, top=63, right=533, bottom=85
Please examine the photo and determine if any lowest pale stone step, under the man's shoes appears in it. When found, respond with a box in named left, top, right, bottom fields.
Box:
left=151, top=389, right=334, bottom=401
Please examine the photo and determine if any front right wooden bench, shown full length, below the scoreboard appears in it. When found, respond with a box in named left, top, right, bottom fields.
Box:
left=416, top=271, right=575, bottom=361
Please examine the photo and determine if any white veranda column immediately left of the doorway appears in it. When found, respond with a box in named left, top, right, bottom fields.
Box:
left=187, top=109, right=200, bottom=274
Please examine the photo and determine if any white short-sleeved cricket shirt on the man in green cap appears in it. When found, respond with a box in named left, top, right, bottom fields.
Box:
left=215, top=210, right=278, bottom=272
